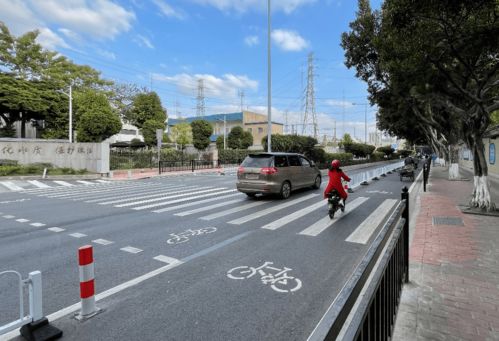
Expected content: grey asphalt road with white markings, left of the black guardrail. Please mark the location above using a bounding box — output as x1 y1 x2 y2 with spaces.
0 163 420 340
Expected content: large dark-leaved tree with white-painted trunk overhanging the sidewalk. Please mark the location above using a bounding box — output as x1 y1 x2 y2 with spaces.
342 0 499 210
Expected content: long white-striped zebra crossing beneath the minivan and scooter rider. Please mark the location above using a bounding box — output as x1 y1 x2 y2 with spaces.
16 181 398 240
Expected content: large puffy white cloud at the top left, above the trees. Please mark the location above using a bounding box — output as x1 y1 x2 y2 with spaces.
27 0 135 39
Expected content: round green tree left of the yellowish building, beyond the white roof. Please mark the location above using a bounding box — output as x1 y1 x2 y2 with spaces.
124 92 167 129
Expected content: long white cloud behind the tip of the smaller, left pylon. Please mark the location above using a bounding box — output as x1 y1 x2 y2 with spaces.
153 73 258 99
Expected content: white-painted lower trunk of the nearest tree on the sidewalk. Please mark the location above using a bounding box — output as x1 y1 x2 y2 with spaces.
470 137 495 211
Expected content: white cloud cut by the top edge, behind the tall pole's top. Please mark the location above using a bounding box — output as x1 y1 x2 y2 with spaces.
191 0 317 14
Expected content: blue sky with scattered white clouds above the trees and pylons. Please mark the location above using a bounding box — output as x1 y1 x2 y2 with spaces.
0 0 381 141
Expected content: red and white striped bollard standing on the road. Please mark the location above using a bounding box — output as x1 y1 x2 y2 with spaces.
76 245 99 320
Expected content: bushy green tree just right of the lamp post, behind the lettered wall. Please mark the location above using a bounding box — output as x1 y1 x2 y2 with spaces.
77 91 121 142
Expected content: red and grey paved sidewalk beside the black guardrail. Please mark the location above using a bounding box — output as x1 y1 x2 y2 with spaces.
393 167 499 341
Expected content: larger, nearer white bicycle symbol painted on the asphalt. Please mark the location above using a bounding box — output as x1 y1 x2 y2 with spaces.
227 262 302 293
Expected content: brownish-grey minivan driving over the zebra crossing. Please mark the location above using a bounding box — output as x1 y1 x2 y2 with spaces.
236 153 322 199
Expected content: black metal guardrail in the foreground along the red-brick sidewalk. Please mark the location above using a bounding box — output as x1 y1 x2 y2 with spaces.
308 187 409 341
